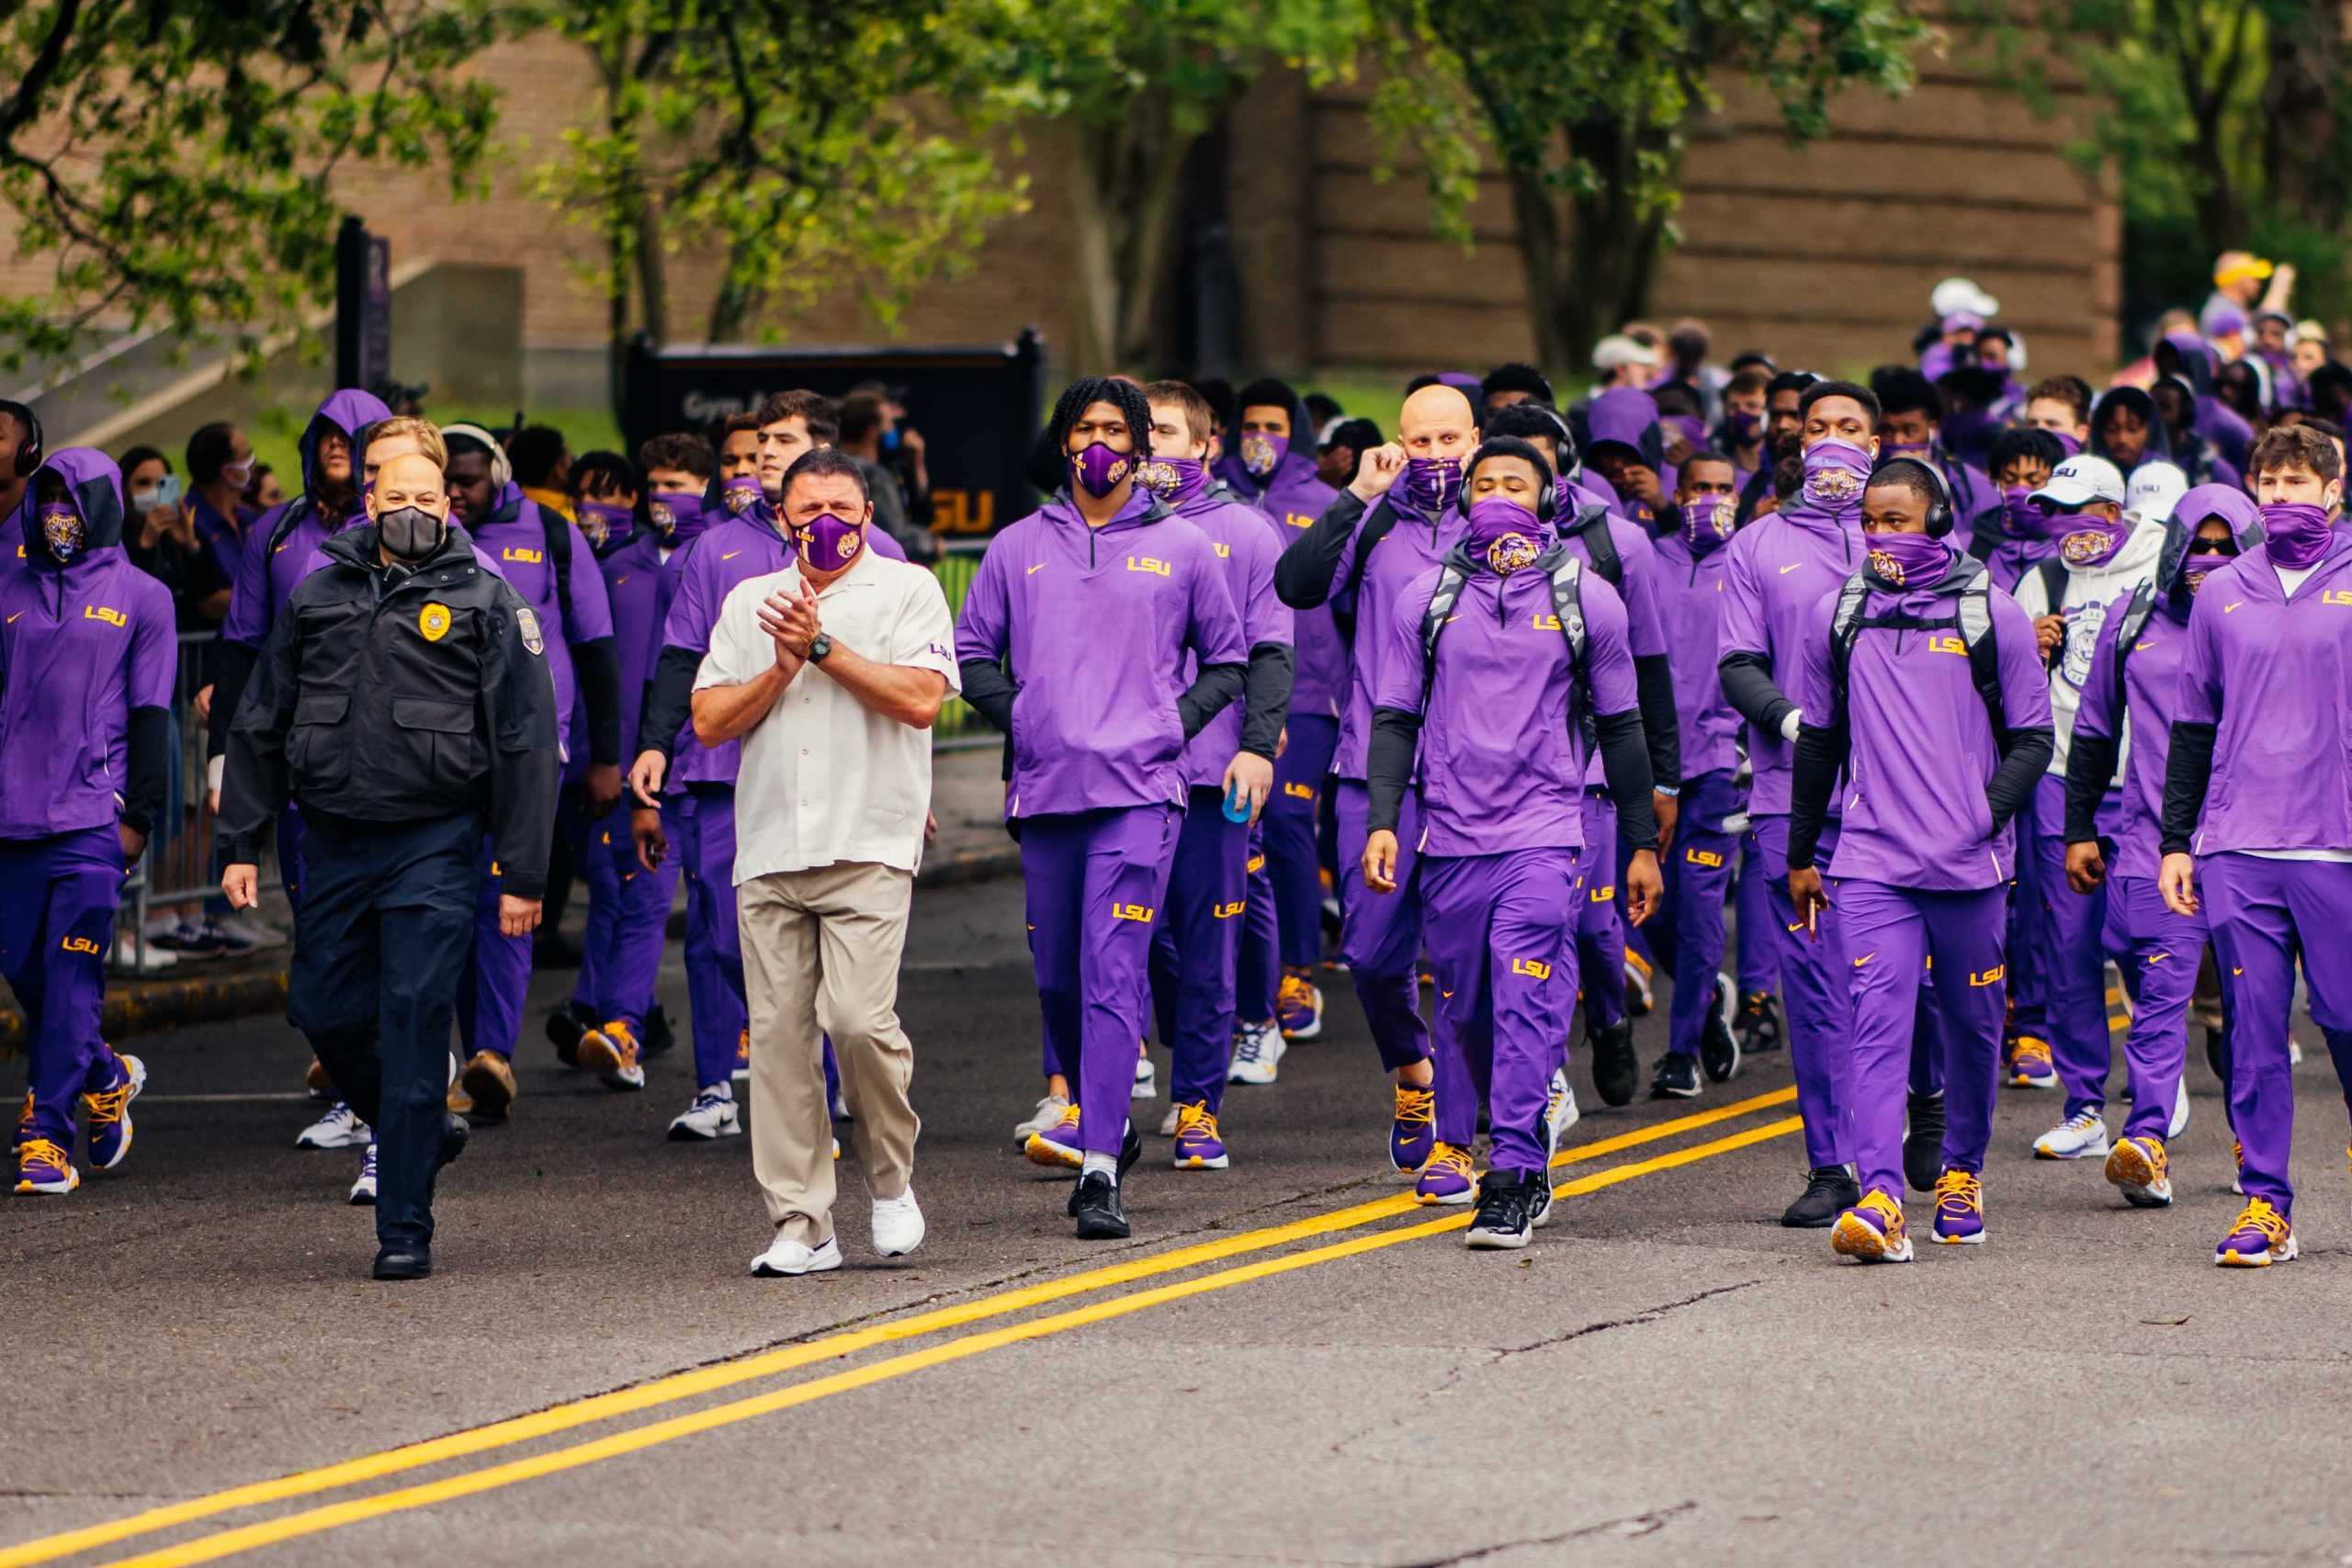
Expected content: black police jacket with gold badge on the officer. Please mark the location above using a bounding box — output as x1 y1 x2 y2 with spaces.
219 525 562 898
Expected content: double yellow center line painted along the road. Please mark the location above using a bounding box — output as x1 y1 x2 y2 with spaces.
0 1089 1802 1568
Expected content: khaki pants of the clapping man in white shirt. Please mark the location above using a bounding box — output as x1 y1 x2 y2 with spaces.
736 863 922 1246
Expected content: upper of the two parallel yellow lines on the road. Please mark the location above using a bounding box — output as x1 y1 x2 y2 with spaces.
0 1089 1797 1568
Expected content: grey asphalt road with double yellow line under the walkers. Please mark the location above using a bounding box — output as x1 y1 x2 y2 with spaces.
0 882 2352 1568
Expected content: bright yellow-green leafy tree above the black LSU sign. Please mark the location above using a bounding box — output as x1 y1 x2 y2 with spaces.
537 0 1030 400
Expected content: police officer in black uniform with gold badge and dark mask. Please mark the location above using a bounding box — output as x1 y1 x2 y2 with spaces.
219 456 560 1279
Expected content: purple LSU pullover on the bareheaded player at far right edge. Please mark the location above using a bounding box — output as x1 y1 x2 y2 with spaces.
2173 525 2352 856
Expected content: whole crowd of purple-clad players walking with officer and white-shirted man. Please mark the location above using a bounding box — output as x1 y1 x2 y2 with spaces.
0 254 2352 1279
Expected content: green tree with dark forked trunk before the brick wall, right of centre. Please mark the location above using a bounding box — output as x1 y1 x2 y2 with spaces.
1374 0 1924 367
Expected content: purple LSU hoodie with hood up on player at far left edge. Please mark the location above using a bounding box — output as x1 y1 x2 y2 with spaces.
0 446 179 841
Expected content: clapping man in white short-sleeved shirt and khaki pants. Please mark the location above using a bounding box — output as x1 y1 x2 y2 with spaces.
694 449 959 1274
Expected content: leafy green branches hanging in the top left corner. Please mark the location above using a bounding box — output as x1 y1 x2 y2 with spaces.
0 0 496 369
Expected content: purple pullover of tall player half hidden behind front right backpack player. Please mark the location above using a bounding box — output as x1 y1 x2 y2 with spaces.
1714 491 1862 818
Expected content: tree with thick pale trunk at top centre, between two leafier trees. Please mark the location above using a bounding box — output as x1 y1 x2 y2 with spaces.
1004 0 1371 367
